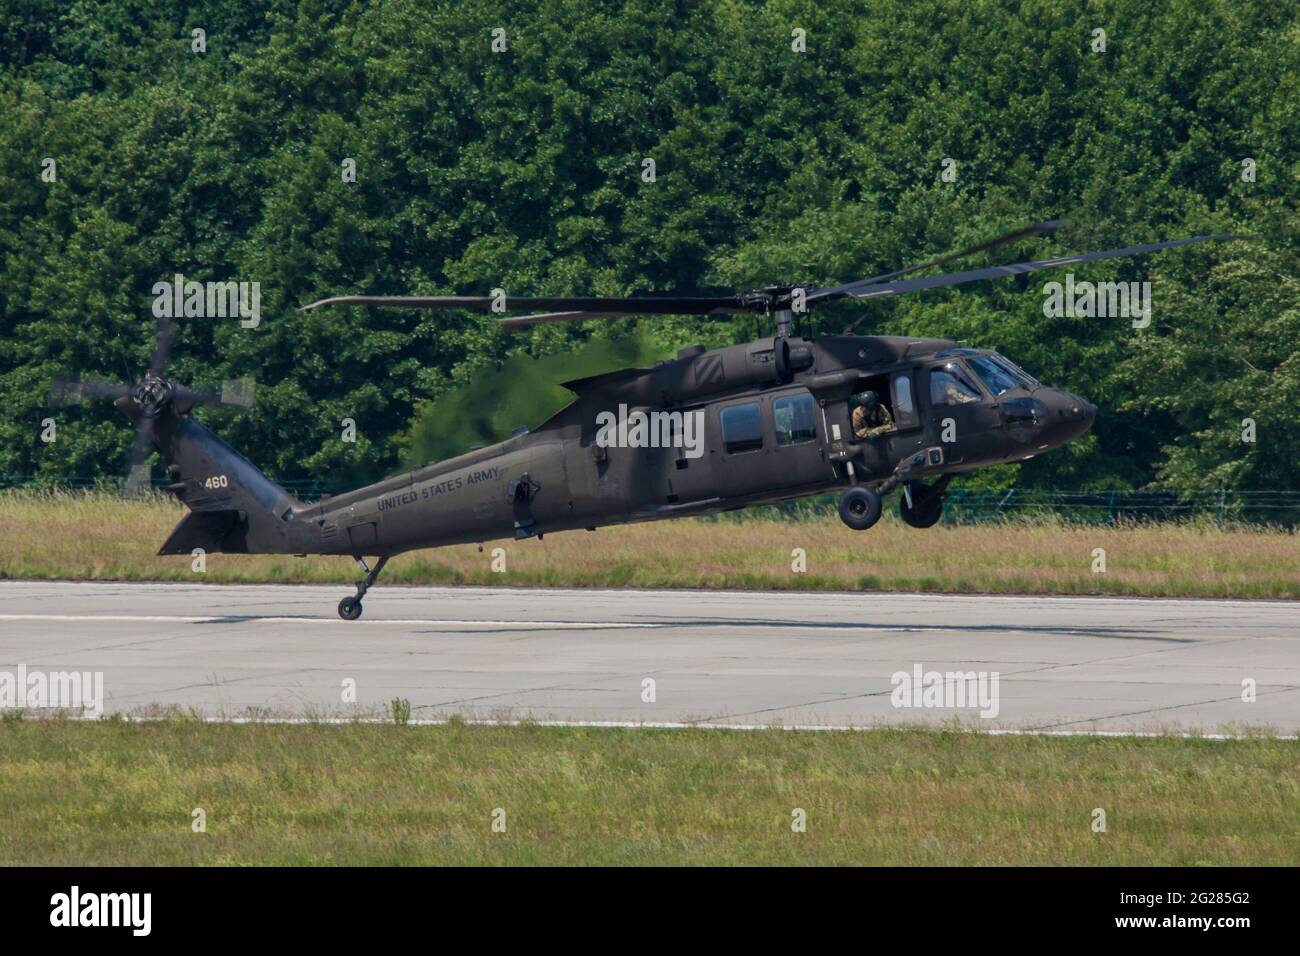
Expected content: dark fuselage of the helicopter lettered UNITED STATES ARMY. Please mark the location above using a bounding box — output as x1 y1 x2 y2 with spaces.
282 336 1096 555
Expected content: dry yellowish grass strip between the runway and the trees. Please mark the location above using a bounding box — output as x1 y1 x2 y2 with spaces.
0 492 1300 598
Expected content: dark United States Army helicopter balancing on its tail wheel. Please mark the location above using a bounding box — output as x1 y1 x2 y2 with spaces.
53 220 1234 620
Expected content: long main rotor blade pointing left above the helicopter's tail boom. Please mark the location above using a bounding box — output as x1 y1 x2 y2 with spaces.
298 295 763 321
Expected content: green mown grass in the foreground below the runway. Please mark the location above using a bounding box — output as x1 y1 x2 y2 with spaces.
0 719 1300 865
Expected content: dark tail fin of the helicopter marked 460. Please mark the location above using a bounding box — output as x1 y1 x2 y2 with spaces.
155 411 307 554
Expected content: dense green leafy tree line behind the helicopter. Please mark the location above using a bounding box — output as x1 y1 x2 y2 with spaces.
0 0 1300 489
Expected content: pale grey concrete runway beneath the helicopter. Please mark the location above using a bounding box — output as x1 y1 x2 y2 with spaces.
0 581 1300 734
